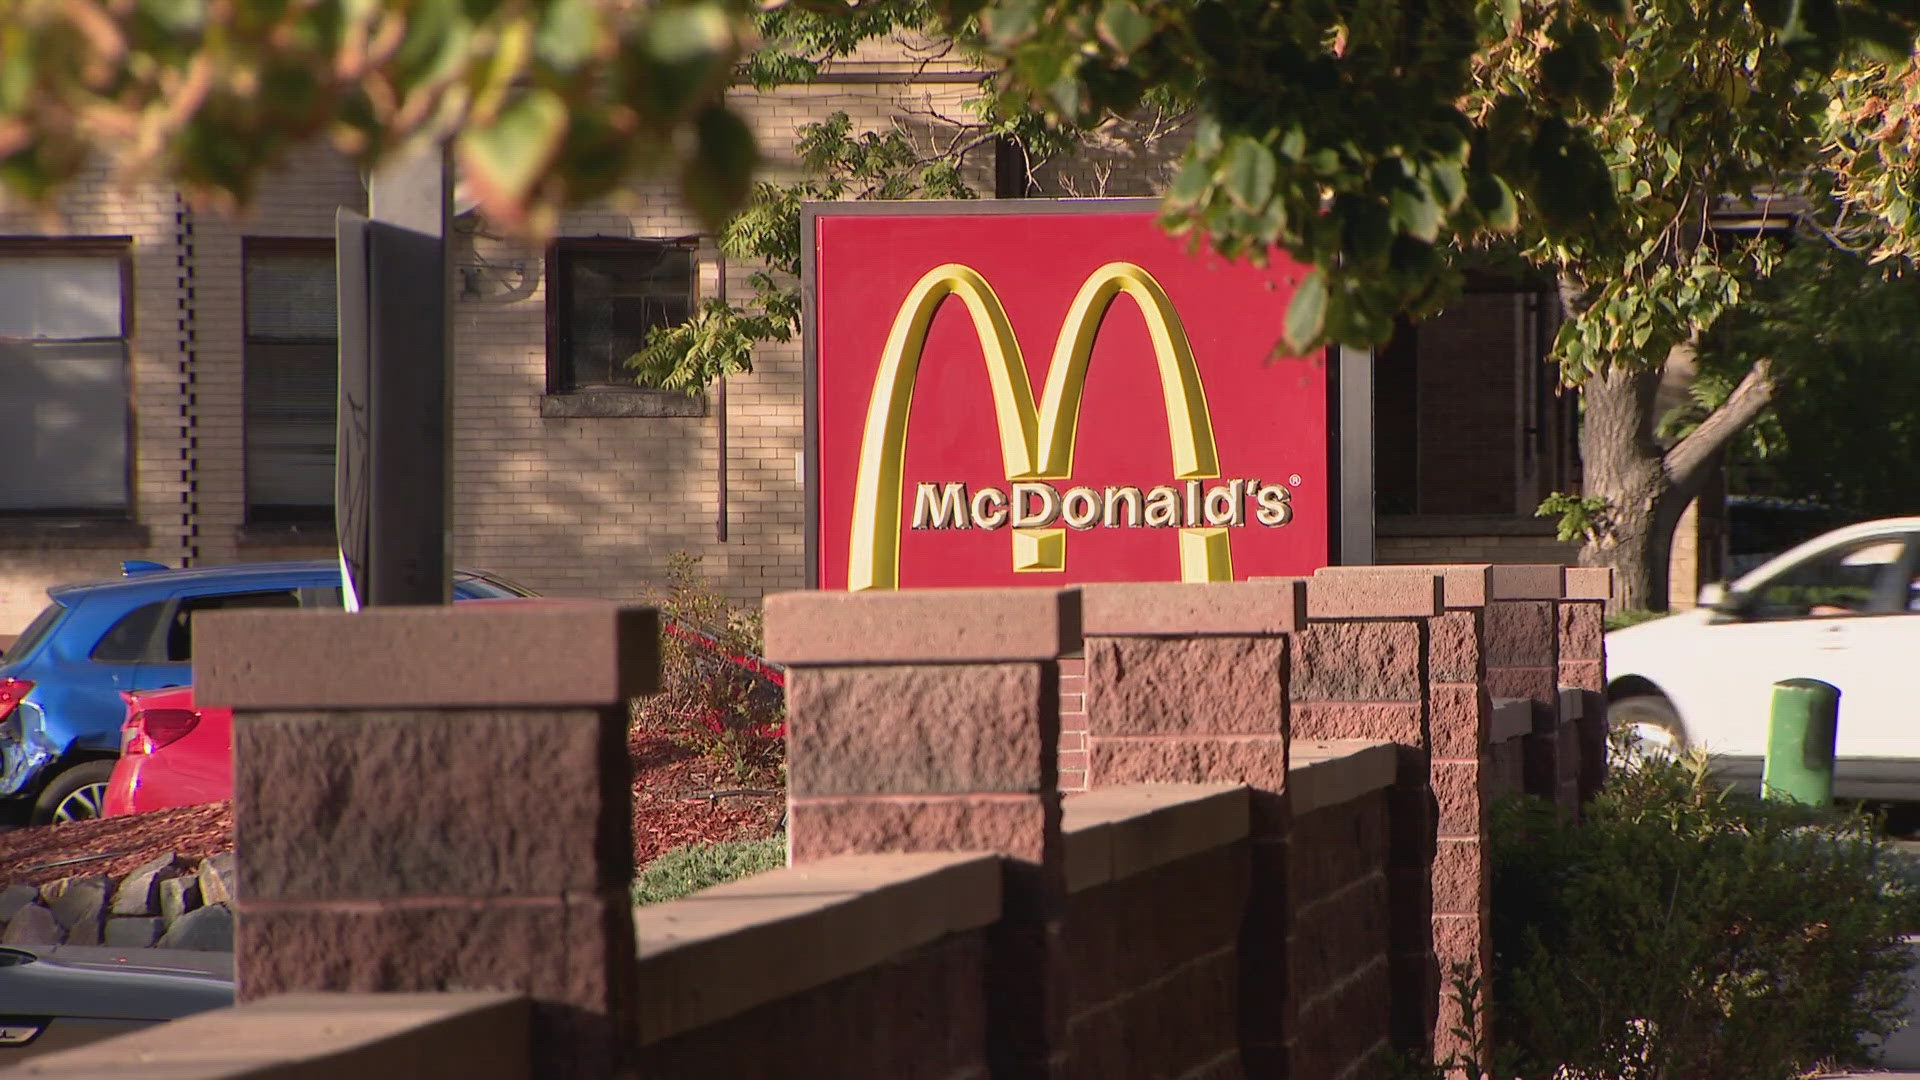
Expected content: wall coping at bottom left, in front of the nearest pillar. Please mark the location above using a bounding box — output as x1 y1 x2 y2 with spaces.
13 990 534 1080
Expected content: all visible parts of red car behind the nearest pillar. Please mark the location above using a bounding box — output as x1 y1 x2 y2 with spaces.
102 614 787 817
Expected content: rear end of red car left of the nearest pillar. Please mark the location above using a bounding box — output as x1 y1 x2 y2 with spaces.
102 686 234 817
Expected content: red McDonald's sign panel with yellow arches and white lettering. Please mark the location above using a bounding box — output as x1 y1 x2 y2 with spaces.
804 200 1338 590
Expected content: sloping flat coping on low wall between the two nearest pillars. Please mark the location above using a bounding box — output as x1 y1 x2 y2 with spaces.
634 851 1002 1045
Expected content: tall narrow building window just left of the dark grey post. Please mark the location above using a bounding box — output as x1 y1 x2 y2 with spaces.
242 238 340 525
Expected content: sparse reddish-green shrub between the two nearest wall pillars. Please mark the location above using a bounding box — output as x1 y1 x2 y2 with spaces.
634 553 787 786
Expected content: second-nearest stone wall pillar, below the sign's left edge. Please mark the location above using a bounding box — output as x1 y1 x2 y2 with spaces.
766 588 1081 1078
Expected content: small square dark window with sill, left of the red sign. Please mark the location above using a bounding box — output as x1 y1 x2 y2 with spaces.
547 238 693 394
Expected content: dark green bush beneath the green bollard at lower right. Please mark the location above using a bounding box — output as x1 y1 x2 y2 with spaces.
1490 759 1920 1080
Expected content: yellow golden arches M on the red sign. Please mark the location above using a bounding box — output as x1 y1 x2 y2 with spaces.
847 263 1233 590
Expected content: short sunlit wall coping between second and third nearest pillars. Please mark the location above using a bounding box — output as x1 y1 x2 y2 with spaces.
1062 784 1250 892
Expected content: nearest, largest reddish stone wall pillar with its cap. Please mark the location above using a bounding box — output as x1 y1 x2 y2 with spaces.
194 601 659 1078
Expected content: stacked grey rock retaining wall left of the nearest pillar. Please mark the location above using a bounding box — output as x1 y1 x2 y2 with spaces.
0 851 234 951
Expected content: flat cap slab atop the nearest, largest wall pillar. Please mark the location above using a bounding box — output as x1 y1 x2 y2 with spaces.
194 600 660 709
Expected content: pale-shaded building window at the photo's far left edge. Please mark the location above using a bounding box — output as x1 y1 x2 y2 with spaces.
0 238 132 519
